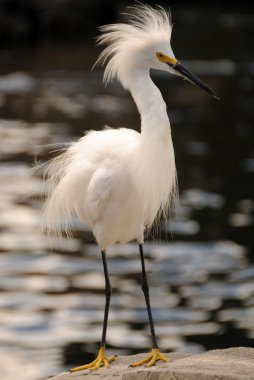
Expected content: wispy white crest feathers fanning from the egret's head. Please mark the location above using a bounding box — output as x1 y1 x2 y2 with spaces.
94 3 172 84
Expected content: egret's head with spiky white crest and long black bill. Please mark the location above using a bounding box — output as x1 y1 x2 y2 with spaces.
96 3 218 99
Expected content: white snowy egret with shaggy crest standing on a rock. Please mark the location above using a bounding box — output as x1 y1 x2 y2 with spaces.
44 3 217 372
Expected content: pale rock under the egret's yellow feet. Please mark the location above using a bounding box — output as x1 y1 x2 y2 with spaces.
46 347 254 380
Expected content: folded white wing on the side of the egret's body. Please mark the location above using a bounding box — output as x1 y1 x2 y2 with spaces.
87 168 115 222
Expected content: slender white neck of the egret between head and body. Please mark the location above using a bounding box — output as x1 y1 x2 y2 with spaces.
129 70 170 140
